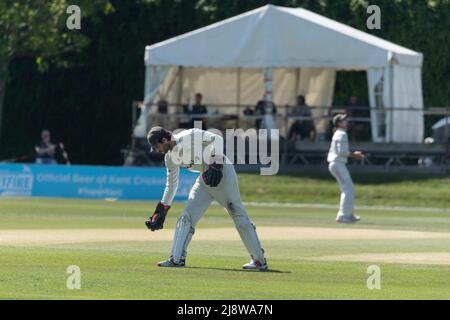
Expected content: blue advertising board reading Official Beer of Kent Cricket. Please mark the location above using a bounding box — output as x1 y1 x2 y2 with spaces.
0 164 198 200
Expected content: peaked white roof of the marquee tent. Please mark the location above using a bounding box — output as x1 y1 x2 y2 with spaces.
146 4 423 69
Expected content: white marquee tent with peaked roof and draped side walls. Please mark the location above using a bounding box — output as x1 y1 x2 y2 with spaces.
135 5 423 143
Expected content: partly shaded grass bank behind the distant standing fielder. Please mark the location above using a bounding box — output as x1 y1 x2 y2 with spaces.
239 172 450 208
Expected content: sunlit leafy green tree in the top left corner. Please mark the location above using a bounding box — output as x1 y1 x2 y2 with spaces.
0 0 112 138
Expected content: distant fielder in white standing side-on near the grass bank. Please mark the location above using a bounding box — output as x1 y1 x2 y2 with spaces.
327 114 364 223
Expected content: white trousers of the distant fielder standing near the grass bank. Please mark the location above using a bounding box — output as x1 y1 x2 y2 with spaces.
328 161 355 217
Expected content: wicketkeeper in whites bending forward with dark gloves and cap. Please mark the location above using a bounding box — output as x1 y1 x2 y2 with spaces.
146 127 268 271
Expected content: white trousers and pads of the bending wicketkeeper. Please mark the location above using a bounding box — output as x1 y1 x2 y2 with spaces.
171 164 265 263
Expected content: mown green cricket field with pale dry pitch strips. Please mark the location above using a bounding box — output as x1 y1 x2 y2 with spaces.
0 184 450 299
